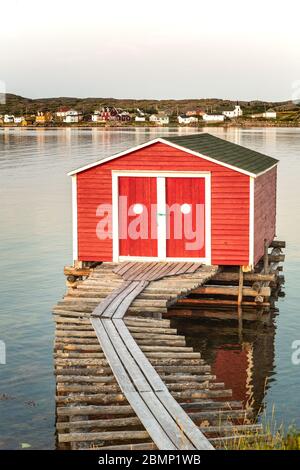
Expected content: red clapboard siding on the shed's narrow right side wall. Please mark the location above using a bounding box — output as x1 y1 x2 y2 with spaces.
254 167 277 264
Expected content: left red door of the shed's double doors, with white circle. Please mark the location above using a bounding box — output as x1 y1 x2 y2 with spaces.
118 176 157 257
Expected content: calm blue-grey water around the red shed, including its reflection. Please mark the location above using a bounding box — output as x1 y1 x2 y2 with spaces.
0 129 300 449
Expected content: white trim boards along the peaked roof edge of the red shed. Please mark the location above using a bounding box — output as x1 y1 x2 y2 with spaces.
68 137 278 178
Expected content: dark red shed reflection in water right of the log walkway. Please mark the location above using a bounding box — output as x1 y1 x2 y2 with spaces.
172 314 275 416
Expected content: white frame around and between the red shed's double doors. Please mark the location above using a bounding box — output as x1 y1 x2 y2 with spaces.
112 170 211 265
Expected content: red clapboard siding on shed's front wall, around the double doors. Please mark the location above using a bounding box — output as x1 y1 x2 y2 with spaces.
77 143 249 265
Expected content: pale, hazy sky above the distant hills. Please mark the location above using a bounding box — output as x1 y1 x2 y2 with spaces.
0 0 300 101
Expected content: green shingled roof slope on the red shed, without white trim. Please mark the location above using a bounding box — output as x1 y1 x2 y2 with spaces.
162 133 278 175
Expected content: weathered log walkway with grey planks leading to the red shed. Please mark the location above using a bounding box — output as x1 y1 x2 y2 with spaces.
54 262 258 450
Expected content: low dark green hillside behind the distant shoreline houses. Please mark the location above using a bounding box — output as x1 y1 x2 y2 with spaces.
0 93 300 115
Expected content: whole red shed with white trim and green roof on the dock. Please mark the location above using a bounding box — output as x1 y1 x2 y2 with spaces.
69 133 278 270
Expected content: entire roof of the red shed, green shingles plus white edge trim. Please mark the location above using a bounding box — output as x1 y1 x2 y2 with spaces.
68 133 278 177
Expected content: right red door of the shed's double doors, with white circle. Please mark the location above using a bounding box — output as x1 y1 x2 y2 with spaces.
166 177 205 258
